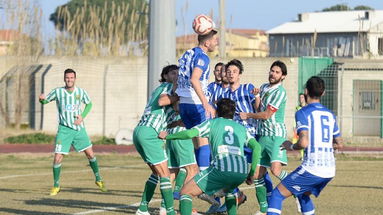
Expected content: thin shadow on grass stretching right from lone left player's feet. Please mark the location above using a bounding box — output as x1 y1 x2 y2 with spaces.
61 187 142 198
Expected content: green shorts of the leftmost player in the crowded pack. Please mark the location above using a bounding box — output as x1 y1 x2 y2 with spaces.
133 126 168 165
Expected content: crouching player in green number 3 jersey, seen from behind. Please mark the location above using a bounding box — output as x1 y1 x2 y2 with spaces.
166 99 260 215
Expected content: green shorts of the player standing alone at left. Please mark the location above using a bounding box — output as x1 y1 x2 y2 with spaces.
55 125 92 154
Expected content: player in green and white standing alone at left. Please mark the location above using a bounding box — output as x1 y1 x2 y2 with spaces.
39 69 107 196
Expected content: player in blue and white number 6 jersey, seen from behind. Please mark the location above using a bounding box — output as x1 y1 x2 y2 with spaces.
267 76 343 215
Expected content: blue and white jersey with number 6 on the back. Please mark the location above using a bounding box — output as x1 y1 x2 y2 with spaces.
295 103 340 178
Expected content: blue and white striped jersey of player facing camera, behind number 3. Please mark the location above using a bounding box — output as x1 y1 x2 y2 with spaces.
219 84 257 136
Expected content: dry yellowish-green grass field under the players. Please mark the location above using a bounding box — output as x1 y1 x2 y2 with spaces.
0 153 383 215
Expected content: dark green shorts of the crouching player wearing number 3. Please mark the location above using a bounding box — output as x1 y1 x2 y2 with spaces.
194 166 247 195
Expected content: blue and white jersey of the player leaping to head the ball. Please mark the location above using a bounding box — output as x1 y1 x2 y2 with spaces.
176 47 210 104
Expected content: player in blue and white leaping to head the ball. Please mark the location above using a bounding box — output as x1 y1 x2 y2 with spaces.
176 29 218 173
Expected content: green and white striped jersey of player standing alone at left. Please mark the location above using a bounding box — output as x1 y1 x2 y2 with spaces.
46 87 91 130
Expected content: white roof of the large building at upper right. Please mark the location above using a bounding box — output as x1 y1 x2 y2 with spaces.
267 10 383 34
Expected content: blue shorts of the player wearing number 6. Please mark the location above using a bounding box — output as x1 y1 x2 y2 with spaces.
281 166 332 197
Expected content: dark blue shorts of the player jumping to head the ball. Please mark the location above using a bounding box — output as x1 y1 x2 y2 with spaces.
179 104 206 129
